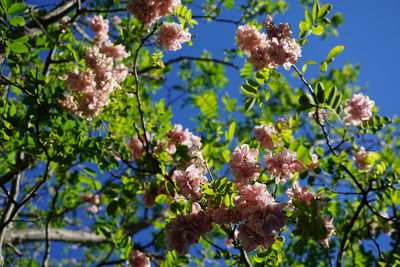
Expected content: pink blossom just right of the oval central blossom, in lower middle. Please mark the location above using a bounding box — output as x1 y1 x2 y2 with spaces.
264 148 304 184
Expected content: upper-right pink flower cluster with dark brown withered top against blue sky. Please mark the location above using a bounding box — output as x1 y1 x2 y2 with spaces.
236 16 301 71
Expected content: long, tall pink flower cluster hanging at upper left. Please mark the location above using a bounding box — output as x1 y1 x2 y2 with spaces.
59 16 129 118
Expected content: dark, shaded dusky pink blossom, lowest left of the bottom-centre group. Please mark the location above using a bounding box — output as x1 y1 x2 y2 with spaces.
165 211 212 255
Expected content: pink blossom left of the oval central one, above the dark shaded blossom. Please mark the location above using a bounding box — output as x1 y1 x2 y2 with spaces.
172 165 208 200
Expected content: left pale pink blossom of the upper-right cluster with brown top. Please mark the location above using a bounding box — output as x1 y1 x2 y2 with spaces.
236 24 265 54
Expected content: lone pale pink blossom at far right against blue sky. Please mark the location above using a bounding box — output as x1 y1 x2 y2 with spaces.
343 93 375 126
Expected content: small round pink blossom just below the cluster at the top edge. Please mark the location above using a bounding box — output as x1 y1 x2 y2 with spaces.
157 22 191 51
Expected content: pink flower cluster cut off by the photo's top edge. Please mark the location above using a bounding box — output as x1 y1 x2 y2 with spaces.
126 0 181 25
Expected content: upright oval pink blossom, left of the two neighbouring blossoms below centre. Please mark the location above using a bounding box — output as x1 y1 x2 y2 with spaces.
229 144 260 184
